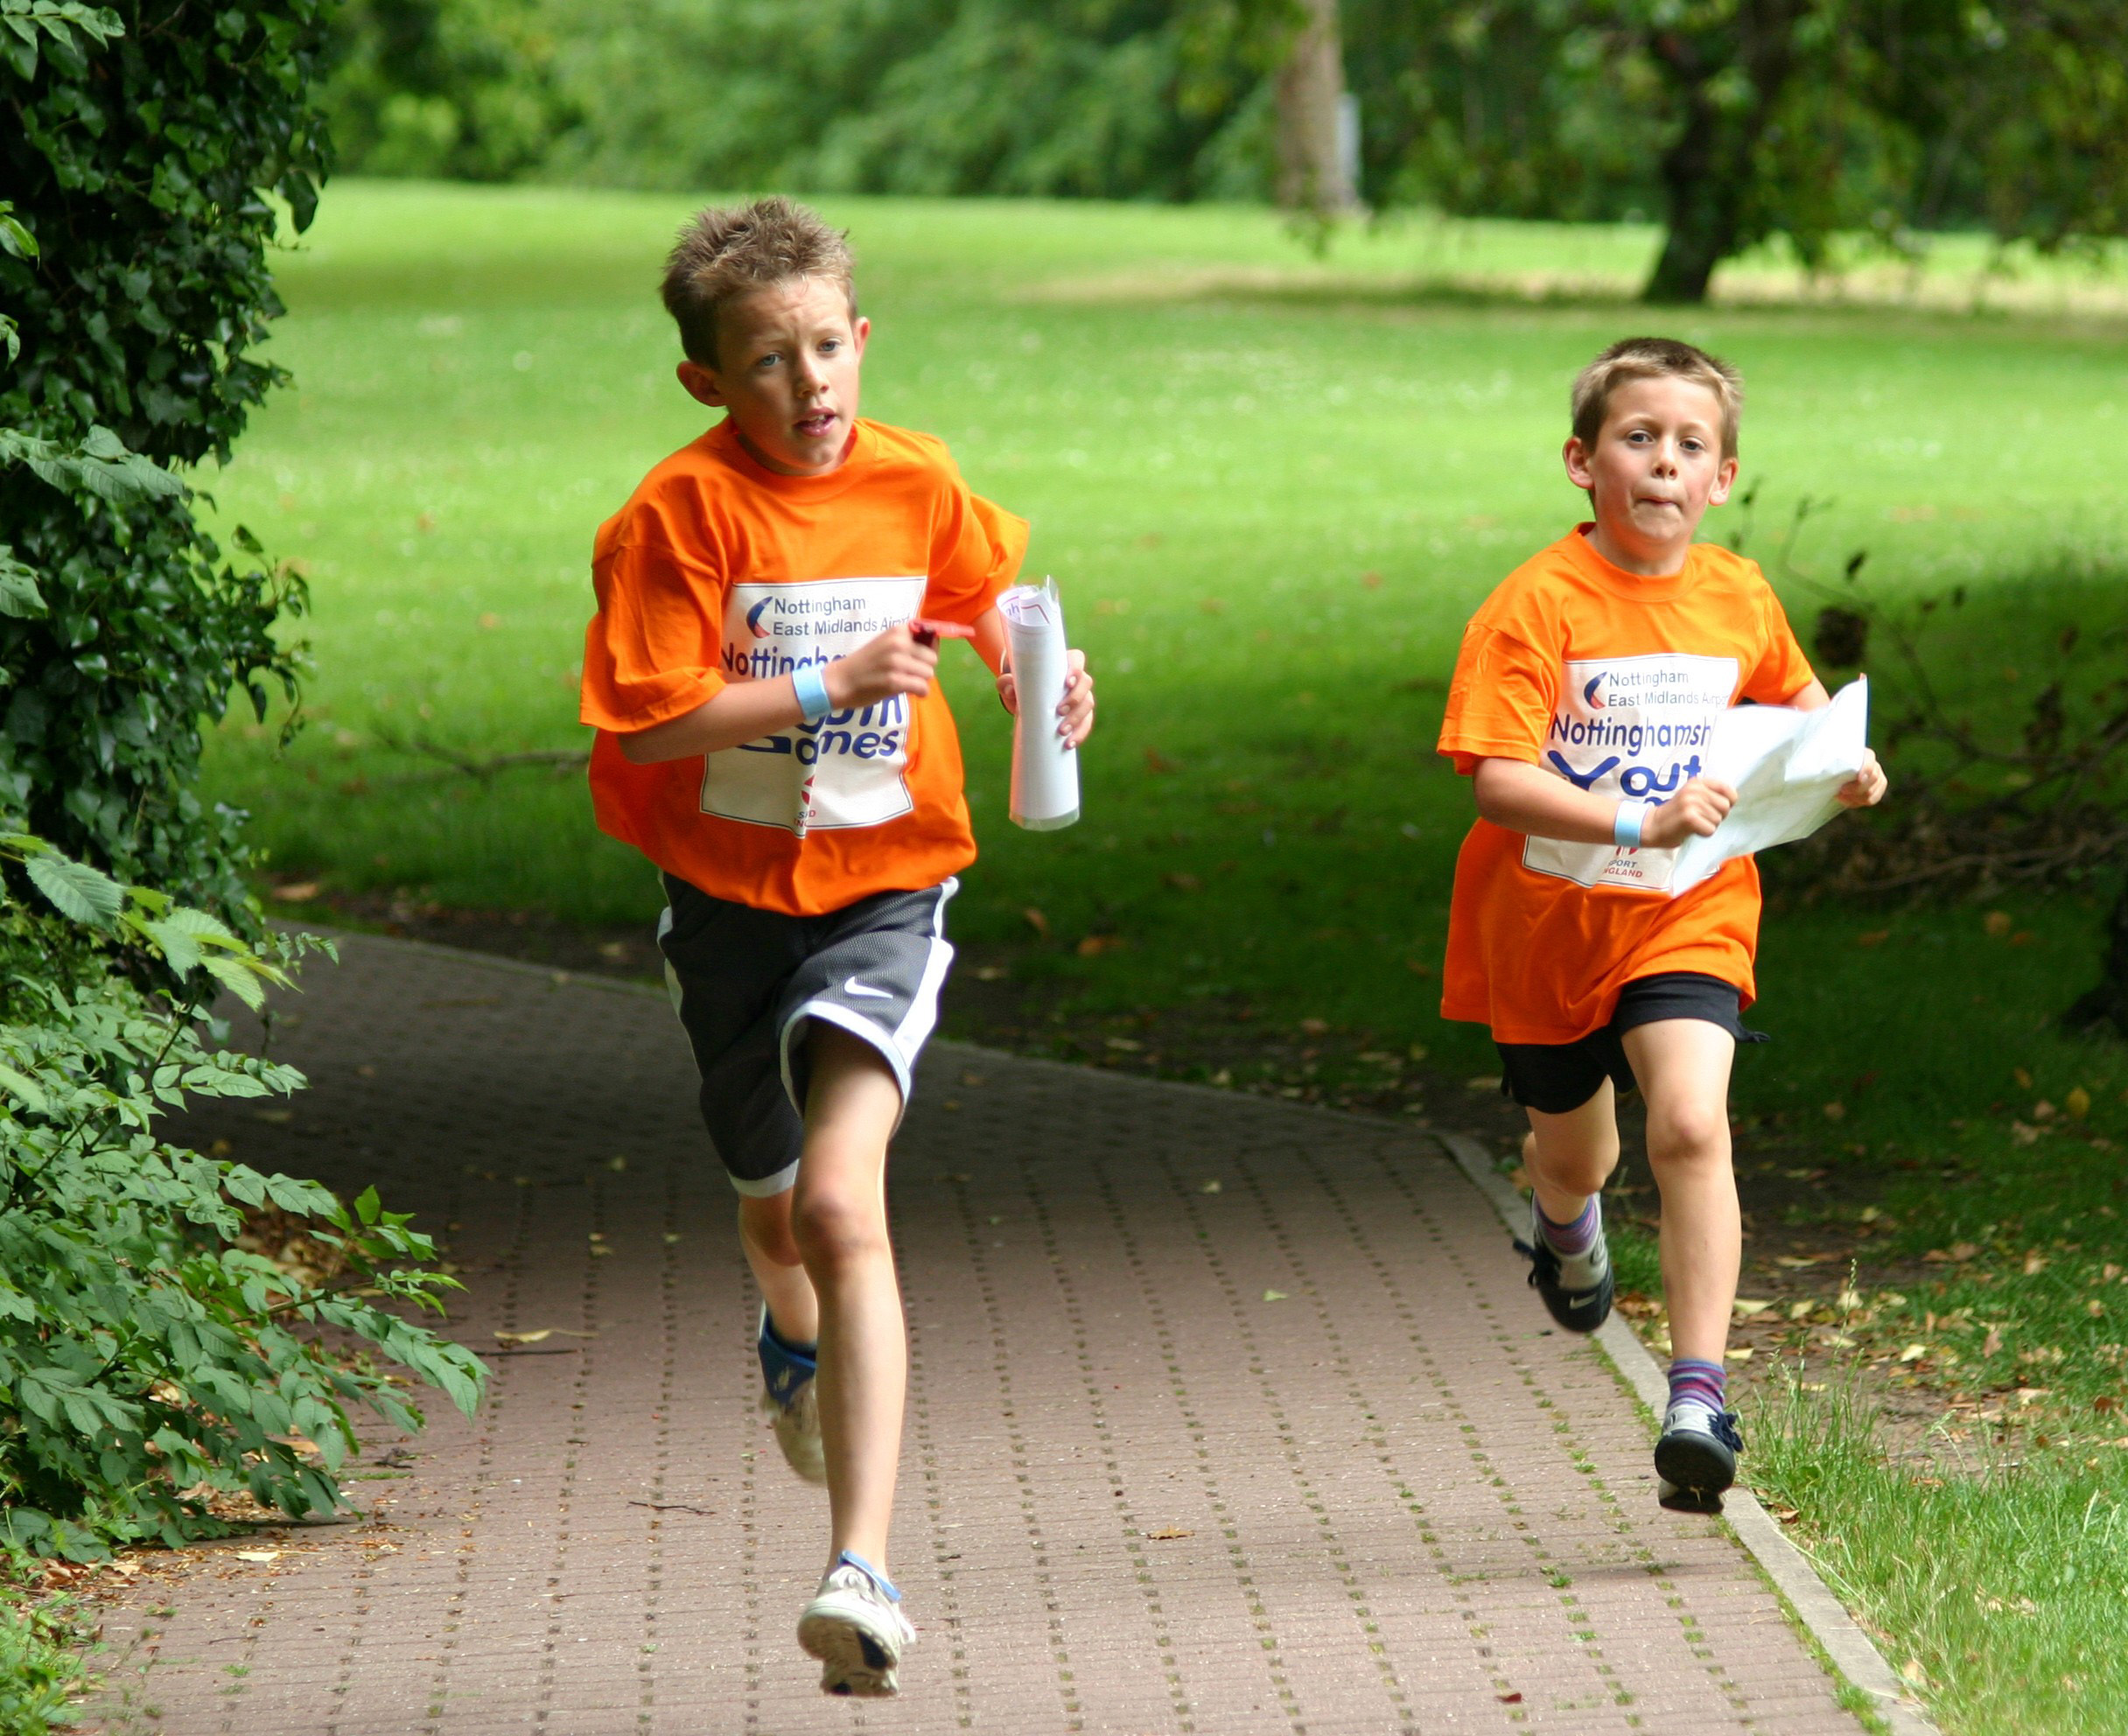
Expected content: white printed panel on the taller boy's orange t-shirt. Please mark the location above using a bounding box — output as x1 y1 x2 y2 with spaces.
703 574 928 838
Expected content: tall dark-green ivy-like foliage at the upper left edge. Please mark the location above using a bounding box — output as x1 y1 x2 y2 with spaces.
0 0 328 914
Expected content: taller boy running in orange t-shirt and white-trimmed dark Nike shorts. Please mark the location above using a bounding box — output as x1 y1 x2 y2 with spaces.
583 198 1094 1696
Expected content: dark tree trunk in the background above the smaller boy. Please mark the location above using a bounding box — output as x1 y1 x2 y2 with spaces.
1641 0 1809 304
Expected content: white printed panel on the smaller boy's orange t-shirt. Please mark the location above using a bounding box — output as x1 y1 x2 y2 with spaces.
1522 651 1739 892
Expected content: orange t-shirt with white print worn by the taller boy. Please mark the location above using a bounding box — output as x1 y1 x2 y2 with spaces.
581 419 1028 917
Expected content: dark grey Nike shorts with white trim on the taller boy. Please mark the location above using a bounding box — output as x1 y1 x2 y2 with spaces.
657 874 960 1198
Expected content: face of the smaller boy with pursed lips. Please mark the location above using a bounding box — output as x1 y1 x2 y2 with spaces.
1566 376 1737 570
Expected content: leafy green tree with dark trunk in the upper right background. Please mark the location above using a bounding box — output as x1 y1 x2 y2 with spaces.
1345 0 2128 302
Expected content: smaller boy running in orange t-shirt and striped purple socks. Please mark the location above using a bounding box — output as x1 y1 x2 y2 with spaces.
1440 339 1886 1513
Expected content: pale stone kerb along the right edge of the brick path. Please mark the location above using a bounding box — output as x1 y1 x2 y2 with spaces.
1432 1131 1942 1736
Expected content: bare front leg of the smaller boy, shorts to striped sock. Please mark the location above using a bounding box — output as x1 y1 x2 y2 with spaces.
1624 1019 1743 1368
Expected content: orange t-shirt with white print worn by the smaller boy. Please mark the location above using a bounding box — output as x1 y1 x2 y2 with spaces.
1440 526 1811 1042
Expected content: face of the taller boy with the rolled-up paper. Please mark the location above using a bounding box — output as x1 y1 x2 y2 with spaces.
679 276 872 477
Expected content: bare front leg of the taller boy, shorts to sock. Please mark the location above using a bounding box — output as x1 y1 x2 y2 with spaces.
792 1019 908 1572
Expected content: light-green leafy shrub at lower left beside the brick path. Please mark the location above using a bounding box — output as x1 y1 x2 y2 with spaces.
0 832 485 1559
